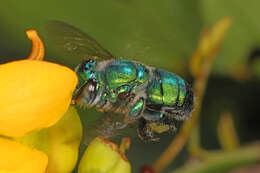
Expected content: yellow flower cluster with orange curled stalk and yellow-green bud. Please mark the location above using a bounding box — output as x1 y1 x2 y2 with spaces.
0 30 131 173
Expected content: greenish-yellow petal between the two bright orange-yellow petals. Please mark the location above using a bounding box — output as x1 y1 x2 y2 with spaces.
16 106 82 173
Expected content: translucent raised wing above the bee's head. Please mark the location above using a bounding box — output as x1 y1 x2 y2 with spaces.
46 21 113 61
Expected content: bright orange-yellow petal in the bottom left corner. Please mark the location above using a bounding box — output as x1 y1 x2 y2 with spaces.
0 138 48 173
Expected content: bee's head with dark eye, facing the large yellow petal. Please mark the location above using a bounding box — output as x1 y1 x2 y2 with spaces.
72 59 99 106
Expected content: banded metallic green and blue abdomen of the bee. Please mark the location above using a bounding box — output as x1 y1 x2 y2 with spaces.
147 69 193 117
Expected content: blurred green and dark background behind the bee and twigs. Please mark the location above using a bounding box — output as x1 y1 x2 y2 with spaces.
0 0 260 172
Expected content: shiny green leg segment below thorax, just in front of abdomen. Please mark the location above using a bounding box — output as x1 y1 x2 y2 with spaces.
125 97 145 123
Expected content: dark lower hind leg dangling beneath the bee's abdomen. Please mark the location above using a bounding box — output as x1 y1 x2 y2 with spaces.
137 118 159 142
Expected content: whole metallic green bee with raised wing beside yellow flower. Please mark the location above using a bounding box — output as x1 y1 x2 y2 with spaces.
45 21 194 141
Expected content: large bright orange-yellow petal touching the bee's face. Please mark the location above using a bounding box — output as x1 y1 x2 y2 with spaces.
0 60 77 136
